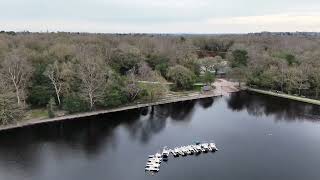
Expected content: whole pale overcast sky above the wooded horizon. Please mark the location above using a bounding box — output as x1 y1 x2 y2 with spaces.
0 0 320 33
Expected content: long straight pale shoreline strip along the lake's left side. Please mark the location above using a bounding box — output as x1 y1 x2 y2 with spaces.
0 92 233 131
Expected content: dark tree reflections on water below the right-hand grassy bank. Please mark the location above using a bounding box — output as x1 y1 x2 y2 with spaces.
228 91 320 122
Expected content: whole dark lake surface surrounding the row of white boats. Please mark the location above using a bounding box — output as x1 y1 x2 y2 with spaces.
0 92 320 180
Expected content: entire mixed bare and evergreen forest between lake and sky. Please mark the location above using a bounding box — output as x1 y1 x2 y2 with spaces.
0 32 320 125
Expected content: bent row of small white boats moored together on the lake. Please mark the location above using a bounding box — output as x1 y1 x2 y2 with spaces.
145 142 218 172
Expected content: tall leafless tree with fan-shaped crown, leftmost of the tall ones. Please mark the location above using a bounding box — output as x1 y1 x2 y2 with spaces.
2 50 32 105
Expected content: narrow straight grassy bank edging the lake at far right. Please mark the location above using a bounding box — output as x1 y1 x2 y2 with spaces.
247 88 320 105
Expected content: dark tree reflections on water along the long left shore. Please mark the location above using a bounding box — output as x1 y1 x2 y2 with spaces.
0 100 200 174
